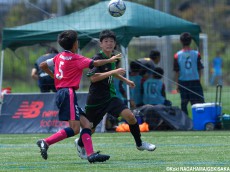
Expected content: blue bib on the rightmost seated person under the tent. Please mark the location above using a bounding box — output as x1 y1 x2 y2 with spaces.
143 78 165 105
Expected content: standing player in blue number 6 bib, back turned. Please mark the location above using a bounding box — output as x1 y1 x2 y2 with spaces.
173 32 204 114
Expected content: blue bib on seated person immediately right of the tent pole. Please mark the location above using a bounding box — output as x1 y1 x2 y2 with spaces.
129 75 142 105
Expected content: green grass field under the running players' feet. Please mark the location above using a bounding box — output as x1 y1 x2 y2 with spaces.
0 131 230 172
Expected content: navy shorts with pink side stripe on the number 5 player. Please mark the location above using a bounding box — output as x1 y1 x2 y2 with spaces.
56 88 85 121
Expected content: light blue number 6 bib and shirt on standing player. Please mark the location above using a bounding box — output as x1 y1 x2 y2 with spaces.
174 49 203 81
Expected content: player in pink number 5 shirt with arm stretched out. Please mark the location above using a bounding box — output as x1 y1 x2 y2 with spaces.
37 30 121 163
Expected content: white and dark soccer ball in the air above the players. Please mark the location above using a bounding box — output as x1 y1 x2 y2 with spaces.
108 0 126 17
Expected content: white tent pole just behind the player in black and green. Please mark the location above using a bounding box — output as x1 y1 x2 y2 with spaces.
121 46 130 108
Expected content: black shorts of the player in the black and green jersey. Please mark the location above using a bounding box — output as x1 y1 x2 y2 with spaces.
85 97 128 128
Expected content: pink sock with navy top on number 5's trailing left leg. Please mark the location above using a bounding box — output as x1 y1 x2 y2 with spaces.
44 127 74 145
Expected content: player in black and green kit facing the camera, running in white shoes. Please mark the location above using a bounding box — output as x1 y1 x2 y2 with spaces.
75 30 156 159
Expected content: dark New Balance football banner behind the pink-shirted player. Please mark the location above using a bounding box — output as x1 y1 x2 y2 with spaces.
0 93 87 134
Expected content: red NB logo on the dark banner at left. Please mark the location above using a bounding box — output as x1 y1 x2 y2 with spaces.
12 101 44 118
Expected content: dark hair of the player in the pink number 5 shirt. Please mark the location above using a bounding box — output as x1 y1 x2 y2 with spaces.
58 30 77 50
